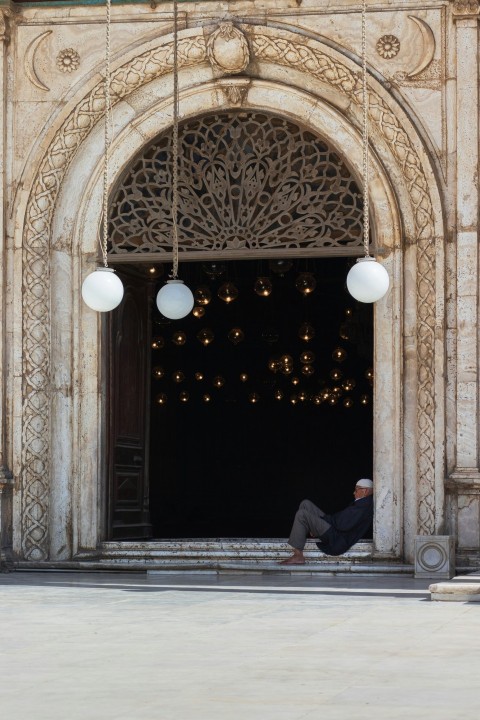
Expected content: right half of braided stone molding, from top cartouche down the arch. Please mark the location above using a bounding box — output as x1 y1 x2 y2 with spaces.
252 35 435 535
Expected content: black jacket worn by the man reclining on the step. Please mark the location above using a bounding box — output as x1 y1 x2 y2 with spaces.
317 495 373 555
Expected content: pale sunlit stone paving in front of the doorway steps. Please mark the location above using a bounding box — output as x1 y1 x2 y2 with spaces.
0 572 480 720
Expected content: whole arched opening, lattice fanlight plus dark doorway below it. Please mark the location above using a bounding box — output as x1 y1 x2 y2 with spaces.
108 111 373 538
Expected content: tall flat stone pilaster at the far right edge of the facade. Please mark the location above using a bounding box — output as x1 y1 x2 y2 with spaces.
447 0 480 564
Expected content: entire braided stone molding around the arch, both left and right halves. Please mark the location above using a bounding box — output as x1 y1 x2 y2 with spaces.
22 29 435 560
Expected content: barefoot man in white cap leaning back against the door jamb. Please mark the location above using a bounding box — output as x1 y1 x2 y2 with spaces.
280 478 373 565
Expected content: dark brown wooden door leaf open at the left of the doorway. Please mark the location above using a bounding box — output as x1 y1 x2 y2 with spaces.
107 268 153 540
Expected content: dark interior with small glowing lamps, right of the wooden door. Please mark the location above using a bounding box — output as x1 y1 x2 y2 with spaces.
149 258 373 539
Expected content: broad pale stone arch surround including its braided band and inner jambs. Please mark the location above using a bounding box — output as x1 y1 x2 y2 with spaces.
22 26 444 559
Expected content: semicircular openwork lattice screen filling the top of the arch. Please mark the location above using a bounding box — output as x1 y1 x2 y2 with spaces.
109 111 363 255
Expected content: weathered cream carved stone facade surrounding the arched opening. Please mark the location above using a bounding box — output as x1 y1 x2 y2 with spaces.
0 0 480 565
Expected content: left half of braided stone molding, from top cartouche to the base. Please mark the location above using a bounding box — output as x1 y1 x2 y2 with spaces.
22 36 205 560
